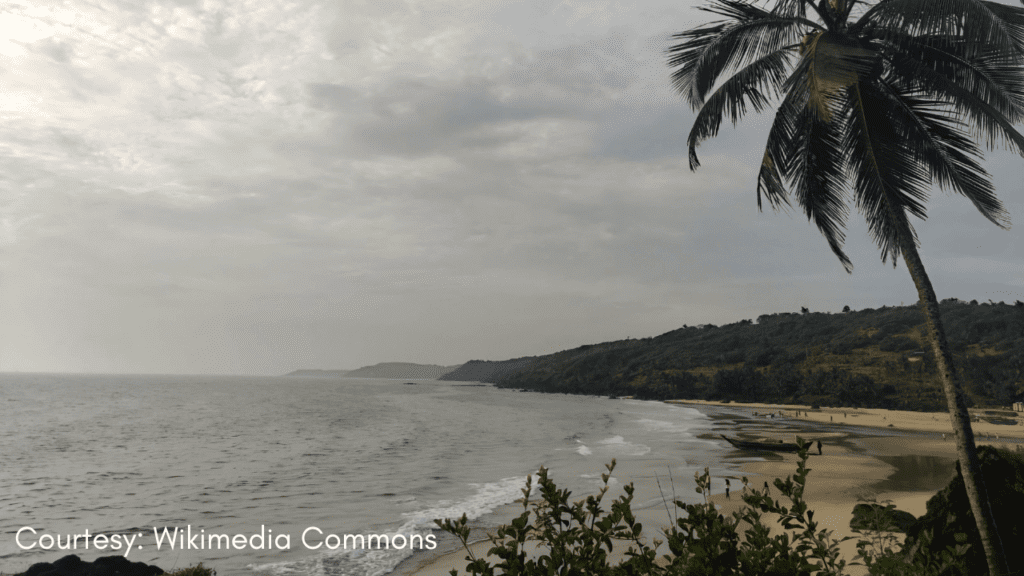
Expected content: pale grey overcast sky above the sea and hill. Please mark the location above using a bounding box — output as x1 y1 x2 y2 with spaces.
0 0 1024 374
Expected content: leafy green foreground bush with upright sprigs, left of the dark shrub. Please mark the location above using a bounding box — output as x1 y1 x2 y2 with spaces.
435 439 849 576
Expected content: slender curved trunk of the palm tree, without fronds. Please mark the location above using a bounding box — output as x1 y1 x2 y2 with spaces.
900 236 1010 576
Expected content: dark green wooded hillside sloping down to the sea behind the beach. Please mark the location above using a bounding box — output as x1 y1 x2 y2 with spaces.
490 298 1024 411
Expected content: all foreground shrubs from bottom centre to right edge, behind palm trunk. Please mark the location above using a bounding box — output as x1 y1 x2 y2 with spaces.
435 446 1024 576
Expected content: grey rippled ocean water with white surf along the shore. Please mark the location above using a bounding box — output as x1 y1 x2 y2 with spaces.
0 374 730 576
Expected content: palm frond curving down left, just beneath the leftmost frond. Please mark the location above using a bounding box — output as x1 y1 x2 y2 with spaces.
687 50 791 170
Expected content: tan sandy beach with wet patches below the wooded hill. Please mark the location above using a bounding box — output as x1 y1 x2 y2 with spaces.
412 401 1024 576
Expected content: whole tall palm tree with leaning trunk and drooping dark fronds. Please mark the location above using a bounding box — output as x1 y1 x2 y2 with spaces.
668 0 1024 575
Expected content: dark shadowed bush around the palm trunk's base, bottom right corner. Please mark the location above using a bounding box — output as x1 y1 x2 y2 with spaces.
903 446 1024 575
